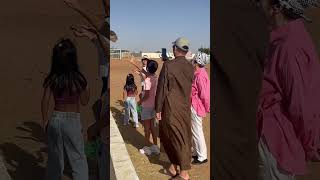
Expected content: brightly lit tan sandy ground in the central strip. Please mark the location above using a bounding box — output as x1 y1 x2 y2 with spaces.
110 60 210 180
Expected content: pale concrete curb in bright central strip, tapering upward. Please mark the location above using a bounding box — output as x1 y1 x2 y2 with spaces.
110 111 139 180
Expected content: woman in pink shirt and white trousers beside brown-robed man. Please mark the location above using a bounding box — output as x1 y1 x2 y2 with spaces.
191 52 210 164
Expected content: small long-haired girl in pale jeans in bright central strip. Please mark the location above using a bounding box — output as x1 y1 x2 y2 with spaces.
123 74 139 128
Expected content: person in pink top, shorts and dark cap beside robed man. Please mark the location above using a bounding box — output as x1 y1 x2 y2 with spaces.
138 60 160 155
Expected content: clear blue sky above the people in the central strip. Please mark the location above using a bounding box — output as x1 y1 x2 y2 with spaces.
110 0 210 52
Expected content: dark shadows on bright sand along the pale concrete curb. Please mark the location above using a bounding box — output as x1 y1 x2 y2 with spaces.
110 100 170 167
